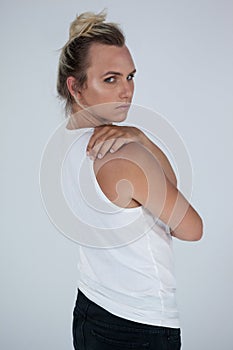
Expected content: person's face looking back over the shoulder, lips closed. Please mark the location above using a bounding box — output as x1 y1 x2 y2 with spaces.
75 44 136 123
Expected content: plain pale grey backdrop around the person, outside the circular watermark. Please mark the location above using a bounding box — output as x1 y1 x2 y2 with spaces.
0 0 233 350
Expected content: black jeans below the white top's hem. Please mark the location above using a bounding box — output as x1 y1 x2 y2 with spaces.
73 290 181 350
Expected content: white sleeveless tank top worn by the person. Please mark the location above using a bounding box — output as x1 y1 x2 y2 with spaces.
62 128 179 328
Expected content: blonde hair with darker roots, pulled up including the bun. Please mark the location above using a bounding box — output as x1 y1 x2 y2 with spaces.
57 11 125 113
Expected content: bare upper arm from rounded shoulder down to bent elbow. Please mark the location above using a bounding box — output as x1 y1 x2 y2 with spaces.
94 143 202 240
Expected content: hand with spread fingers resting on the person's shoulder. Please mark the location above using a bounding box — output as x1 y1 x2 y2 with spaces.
87 125 145 159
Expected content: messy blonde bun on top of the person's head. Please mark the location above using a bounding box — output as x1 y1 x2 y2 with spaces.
69 11 106 41
